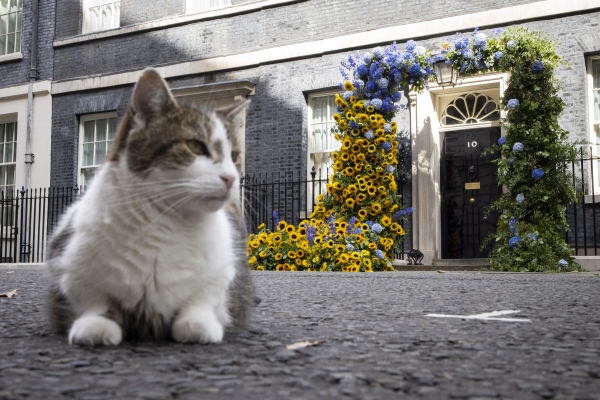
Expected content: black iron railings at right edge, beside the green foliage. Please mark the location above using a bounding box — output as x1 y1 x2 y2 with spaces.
564 150 600 256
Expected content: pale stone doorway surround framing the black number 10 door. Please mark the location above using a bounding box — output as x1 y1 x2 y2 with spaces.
410 73 508 265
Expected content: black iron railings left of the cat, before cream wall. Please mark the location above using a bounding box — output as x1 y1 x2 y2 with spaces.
0 187 79 263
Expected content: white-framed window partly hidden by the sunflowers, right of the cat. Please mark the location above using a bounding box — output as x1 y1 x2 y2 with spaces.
308 94 341 179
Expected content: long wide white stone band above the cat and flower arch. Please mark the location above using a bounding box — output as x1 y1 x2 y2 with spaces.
52 0 600 94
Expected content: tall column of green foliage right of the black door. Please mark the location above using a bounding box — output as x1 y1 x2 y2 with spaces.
486 28 580 272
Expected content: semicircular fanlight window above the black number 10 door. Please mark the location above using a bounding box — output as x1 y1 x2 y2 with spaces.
440 93 500 126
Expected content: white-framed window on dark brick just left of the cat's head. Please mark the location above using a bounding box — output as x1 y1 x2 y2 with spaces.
79 113 117 188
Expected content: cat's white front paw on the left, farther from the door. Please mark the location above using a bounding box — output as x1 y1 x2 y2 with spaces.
69 315 123 346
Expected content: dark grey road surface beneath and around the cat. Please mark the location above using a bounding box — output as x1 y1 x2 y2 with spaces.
0 270 600 400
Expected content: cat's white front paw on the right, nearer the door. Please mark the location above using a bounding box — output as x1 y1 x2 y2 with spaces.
172 314 223 343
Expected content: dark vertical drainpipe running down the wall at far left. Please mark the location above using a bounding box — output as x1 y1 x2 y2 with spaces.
20 0 38 262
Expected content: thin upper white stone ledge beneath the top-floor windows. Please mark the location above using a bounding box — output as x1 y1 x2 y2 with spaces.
52 0 305 47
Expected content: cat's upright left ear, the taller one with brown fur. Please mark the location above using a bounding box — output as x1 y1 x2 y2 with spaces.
131 68 177 120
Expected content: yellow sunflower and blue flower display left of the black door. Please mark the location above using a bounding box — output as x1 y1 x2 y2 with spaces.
247 41 433 272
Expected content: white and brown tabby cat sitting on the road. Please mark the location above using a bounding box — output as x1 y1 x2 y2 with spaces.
47 69 257 345
